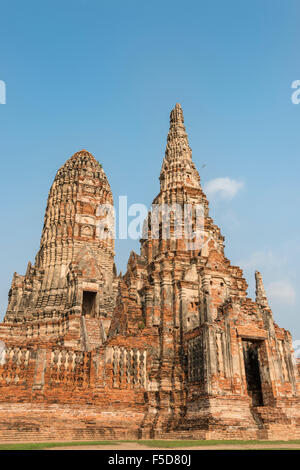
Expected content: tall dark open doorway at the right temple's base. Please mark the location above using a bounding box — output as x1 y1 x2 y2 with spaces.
243 340 263 406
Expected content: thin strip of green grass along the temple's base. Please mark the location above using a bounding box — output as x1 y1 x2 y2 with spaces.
0 440 300 450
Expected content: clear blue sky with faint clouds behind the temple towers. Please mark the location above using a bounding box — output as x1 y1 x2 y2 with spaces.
0 0 300 346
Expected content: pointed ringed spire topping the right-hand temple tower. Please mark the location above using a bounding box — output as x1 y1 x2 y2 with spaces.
160 103 200 191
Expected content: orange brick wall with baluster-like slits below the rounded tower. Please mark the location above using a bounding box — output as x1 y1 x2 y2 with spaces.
0 342 148 409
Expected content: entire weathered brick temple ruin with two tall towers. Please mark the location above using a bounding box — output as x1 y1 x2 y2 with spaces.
0 104 300 441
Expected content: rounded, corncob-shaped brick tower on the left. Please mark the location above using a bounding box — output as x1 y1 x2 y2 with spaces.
6 150 114 321
